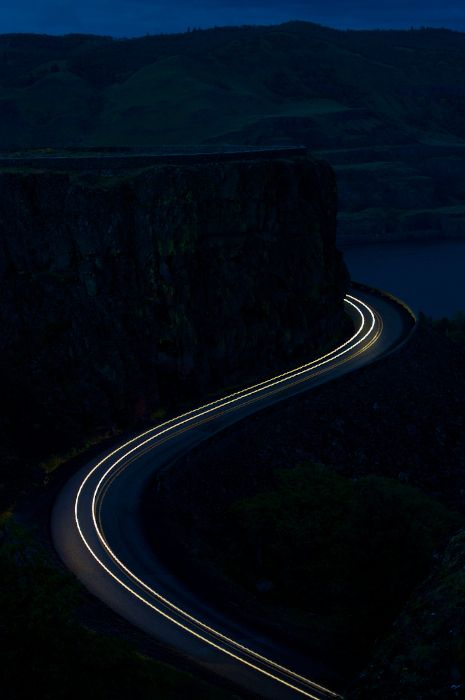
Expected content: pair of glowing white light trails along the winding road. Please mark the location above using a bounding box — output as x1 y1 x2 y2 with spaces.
74 295 376 700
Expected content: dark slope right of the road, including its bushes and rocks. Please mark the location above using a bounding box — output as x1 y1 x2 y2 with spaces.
146 319 465 700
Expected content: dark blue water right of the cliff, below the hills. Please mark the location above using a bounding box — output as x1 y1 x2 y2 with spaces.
340 241 465 318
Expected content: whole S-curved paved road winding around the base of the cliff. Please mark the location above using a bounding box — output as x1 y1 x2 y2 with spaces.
52 292 414 700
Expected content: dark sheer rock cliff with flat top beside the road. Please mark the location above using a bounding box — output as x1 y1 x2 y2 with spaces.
0 152 347 482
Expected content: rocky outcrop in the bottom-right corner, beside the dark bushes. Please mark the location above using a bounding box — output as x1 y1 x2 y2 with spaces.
349 531 465 700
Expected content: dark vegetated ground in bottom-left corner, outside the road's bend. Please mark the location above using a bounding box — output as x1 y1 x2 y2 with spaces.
0 518 230 700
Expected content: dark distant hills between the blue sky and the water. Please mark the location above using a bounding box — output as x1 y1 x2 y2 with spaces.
0 22 465 239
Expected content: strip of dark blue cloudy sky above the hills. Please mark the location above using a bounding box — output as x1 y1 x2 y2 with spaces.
0 0 465 36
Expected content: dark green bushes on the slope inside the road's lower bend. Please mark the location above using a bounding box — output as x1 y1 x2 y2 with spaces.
217 463 462 657
